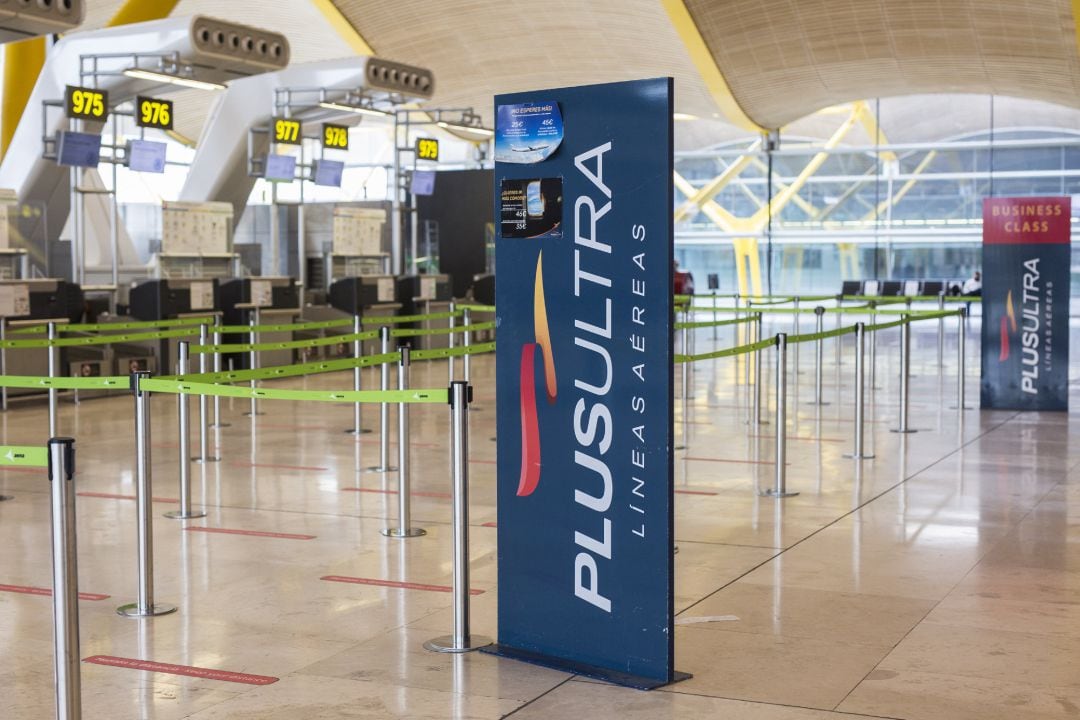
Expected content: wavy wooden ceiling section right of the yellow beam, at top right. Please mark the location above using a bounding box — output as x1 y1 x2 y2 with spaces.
686 0 1080 127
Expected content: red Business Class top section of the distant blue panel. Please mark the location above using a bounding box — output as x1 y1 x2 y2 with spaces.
983 198 1071 245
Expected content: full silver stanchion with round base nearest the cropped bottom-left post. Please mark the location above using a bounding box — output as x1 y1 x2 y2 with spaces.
117 370 176 617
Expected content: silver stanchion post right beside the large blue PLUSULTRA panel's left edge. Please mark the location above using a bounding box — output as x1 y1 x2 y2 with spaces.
423 382 491 653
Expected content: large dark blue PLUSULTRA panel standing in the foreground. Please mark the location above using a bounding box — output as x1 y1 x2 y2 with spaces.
491 78 685 688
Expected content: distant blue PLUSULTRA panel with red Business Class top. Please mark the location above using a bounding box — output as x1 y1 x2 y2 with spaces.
980 198 1072 410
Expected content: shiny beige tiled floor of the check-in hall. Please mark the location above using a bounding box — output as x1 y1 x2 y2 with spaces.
0 321 1080 720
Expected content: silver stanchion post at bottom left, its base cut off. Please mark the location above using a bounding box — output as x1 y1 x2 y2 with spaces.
49 437 82 720
